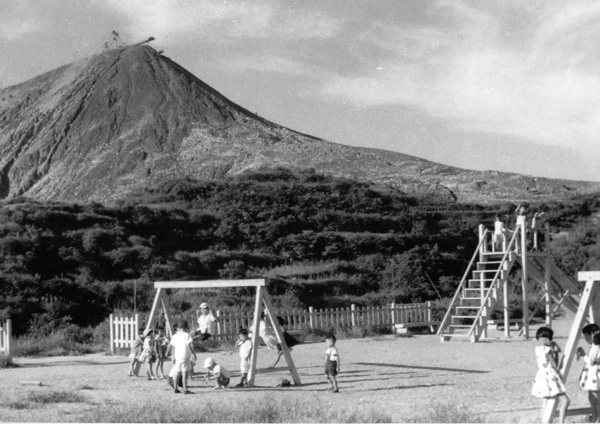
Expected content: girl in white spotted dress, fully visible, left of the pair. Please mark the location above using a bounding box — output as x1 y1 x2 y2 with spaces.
531 327 570 423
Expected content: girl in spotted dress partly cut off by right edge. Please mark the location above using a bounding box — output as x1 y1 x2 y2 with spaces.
577 324 600 423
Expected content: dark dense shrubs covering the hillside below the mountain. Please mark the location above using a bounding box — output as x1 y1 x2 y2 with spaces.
0 169 600 334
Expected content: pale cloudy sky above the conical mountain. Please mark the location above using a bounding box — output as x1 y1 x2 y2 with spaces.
0 0 600 181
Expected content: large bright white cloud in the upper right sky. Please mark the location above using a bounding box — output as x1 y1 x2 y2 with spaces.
324 1 600 150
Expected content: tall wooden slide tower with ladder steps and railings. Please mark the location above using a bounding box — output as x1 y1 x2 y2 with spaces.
438 219 582 342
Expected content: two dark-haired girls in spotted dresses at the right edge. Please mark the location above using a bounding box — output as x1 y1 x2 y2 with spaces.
531 324 600 423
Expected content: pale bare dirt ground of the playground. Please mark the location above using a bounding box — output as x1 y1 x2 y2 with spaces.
0 316 587 422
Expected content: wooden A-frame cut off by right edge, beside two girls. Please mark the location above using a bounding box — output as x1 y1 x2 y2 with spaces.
542 271 600 423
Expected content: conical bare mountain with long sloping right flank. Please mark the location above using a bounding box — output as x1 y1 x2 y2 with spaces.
0 46 600 202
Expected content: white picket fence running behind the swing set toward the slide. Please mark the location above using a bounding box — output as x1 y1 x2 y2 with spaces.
110 302 433 353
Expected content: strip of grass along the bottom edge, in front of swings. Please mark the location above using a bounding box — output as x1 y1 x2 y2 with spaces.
83 396 391 423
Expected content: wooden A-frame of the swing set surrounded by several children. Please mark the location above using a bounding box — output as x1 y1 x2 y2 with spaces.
146 279 301 386
